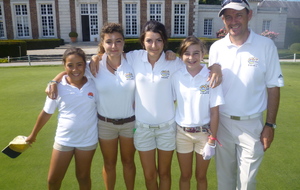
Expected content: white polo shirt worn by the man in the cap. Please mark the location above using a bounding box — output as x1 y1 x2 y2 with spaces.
209 30 284 116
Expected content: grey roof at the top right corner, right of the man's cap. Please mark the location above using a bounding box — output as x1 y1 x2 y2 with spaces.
258 1 300 18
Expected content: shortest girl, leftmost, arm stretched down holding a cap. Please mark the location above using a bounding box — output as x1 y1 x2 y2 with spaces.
26 48 98 189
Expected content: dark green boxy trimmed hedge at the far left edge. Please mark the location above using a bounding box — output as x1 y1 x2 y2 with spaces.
0 40 27 58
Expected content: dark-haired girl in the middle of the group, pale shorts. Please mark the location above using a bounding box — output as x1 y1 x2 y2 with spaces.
126 21 183 190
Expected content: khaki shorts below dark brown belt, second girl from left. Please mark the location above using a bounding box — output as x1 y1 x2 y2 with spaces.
98 119 135 139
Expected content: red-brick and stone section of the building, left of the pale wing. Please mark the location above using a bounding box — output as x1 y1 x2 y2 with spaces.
0 0 197 42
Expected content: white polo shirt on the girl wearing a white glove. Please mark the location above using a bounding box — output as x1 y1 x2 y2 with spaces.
172 64 224 127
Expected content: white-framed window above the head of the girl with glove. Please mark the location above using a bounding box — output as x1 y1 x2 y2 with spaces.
173 3 187 36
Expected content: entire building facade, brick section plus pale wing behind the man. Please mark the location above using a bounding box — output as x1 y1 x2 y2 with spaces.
0 0 296 47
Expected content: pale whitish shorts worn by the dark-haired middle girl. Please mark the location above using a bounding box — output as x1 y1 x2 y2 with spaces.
134 122 176 151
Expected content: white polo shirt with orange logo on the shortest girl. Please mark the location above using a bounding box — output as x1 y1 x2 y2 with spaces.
44 75 98 147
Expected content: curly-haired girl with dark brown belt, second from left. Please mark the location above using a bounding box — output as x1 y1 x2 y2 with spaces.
44 23 136 190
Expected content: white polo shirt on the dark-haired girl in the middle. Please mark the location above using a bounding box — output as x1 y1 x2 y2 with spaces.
126 50 183 124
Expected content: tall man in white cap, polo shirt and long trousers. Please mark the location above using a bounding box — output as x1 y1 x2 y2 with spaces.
209 0 283 190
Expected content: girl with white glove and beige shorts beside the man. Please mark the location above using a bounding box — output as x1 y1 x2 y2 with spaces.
172 36 224 190
